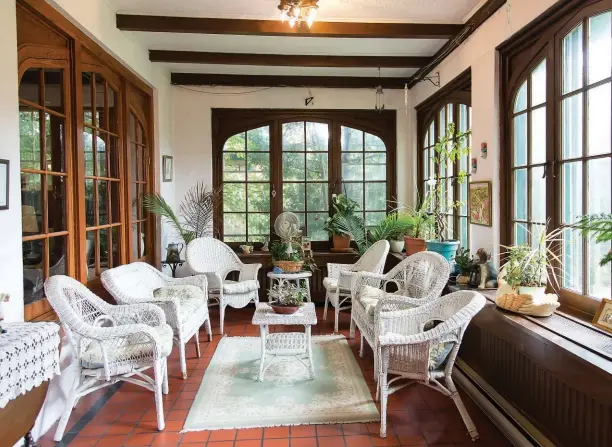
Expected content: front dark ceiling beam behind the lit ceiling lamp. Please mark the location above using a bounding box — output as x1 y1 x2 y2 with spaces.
117 14 462 39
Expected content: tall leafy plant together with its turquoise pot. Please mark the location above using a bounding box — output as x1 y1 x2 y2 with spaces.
426 123 470 261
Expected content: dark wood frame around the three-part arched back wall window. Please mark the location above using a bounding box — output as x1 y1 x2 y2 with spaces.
212 109 397 250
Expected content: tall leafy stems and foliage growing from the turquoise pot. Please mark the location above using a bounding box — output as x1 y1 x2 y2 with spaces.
424 123 471 241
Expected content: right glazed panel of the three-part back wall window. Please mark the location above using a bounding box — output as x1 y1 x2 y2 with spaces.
341 126 388 227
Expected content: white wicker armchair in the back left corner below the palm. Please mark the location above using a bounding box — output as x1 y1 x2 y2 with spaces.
185 237 261 334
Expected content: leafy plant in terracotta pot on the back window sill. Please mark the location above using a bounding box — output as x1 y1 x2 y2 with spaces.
324 194 365 250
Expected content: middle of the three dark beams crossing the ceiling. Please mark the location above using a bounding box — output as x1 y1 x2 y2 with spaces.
149 50 430 68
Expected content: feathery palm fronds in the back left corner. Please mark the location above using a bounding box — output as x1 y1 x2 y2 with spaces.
143 182 221 244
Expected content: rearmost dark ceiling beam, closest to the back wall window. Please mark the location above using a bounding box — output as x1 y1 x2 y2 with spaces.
171 73 406 89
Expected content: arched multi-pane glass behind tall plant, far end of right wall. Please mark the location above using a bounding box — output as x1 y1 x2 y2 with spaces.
420 102 472 247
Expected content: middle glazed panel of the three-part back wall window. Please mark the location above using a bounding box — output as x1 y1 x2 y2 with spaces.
282 121 329 241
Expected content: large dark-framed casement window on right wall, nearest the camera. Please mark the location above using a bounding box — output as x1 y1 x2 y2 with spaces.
501 1 612 314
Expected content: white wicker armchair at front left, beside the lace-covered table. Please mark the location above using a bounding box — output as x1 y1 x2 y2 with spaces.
45 275 172 441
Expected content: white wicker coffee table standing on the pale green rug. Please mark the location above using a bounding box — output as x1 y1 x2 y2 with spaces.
252 303 317 382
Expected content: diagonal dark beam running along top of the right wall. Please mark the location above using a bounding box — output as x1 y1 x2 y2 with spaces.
408 0 506 88
